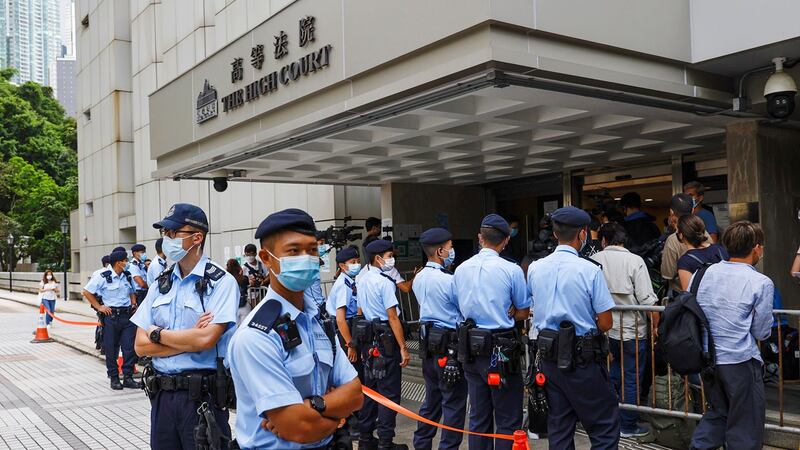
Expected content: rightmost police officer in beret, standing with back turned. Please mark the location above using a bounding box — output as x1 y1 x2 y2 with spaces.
528 206 619 450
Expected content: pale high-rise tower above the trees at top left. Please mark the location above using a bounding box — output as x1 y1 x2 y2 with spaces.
0 0 61 85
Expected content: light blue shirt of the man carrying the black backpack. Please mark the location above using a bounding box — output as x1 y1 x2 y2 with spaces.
692 261 775 364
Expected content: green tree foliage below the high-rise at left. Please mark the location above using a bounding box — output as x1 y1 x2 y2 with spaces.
0 69 78 270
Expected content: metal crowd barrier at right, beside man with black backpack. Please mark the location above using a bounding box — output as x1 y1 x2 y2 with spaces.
607 305 800 435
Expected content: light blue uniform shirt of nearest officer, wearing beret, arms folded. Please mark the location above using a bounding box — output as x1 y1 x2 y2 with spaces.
228 288 358 450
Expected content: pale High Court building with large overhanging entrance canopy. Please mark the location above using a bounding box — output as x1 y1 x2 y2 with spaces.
74 0 800 306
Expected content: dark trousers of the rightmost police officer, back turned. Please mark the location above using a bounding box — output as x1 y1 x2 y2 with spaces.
542 361 619 450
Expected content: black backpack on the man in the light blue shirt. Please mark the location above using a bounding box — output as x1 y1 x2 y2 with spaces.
658 265 716 375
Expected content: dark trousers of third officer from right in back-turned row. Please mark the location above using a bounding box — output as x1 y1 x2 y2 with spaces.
414 356 467 450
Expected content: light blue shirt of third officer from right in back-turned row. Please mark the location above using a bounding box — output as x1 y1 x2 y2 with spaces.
412 262 464 329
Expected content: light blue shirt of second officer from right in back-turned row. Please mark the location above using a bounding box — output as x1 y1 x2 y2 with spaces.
454 248 531 330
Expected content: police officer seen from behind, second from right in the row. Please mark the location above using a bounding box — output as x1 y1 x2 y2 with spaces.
455 214 530 449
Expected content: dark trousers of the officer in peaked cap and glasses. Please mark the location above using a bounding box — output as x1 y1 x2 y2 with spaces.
150 391 231 450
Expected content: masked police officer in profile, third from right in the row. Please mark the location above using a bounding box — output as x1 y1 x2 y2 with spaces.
414 228 467 450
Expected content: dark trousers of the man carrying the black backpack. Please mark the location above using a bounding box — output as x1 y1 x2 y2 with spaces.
692 359 765 450
